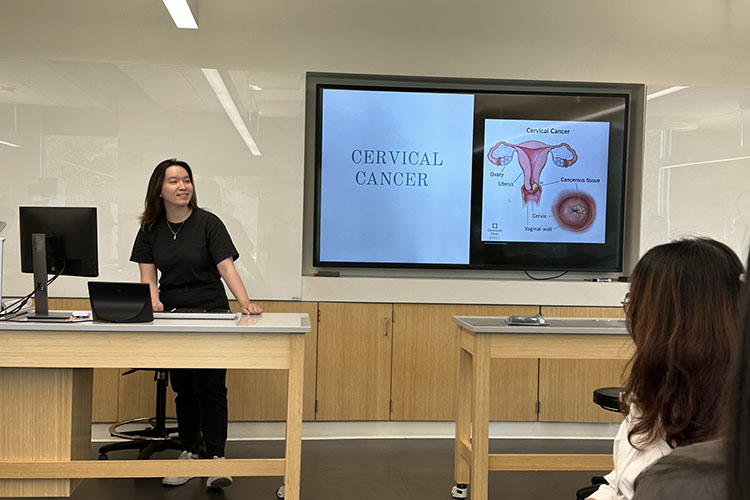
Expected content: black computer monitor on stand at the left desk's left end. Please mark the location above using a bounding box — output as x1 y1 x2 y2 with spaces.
18 207 99 319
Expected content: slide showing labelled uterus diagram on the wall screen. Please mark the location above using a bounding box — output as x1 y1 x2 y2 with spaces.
482 119 609 243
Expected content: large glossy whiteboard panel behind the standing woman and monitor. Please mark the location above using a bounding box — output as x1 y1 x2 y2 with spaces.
0 60 304 299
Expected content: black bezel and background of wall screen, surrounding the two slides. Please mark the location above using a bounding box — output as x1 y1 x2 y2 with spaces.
308 75 632 272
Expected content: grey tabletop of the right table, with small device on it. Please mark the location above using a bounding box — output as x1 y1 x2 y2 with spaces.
453 316 628 335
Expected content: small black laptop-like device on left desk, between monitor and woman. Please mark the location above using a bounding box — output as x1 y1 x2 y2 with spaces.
89 281 154 323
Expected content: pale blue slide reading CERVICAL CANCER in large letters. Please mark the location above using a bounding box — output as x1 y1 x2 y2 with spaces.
319 89 474 264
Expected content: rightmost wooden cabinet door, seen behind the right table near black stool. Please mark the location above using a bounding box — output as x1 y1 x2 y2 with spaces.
539 304 627 422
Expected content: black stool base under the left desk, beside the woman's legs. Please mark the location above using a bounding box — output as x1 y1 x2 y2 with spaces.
99 368 182 460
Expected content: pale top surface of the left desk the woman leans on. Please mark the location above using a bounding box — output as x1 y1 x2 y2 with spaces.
0 313 310 333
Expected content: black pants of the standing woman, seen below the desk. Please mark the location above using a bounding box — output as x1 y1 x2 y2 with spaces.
169 368 228 458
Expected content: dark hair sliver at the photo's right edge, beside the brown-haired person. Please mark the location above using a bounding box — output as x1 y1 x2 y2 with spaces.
727 255 750 500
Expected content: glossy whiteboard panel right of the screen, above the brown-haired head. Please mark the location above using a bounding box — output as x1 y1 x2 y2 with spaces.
641 86 750 262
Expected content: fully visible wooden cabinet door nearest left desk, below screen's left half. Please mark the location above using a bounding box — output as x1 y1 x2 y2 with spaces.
317 302 393 420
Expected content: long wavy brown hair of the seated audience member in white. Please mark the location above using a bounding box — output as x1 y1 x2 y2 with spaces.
623 238 743 447
